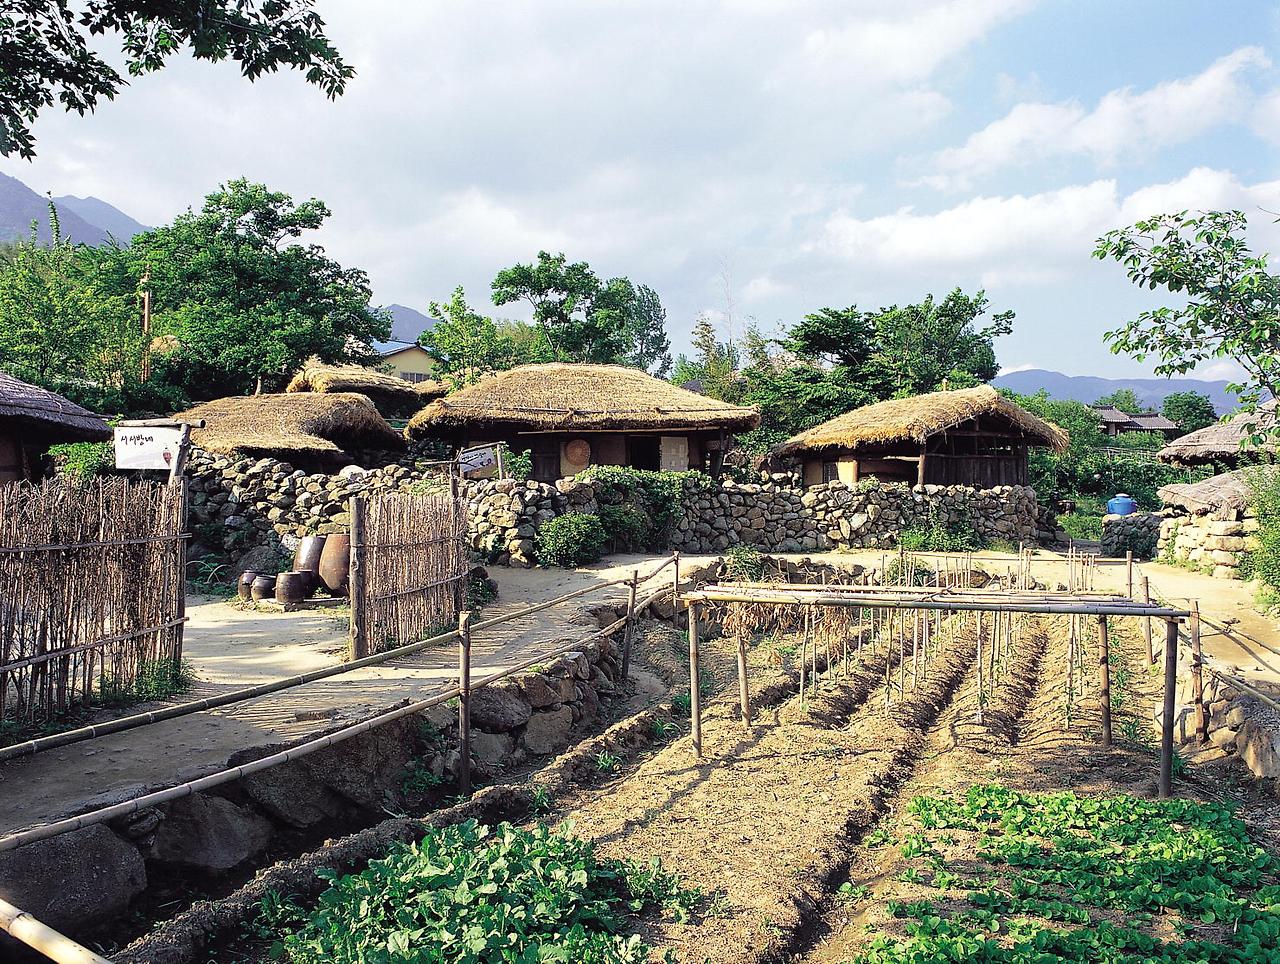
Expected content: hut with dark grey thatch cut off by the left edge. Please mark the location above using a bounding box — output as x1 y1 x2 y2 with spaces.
0 373 111 483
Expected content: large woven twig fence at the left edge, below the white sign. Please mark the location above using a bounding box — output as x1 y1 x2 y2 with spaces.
0 478 184 725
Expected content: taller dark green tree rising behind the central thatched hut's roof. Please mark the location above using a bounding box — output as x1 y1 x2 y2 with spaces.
493 251 671 376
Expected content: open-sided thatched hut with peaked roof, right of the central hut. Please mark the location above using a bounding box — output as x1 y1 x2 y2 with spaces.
773 385 1068 488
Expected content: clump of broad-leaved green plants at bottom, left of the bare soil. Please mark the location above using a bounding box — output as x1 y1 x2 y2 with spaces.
263 821 701 964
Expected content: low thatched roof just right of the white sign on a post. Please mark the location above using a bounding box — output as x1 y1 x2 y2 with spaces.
174 392 404 461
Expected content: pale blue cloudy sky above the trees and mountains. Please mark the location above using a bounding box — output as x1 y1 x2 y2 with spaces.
0 0 1280 378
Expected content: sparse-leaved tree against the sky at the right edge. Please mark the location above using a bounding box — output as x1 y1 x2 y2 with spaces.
1093 211 1280 431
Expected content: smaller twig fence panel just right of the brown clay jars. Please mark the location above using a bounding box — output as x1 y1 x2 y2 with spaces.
351 488 468 659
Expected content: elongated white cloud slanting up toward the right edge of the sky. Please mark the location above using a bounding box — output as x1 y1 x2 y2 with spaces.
925 47 1270 187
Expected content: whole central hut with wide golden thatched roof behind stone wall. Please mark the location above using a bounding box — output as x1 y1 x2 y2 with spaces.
407 362 760 481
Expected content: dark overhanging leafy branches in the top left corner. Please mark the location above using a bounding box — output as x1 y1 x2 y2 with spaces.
0 0 355 157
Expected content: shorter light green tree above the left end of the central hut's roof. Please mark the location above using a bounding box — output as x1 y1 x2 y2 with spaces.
419 287 549 385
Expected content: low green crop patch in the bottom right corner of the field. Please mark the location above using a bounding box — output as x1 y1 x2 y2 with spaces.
856 785 1280 964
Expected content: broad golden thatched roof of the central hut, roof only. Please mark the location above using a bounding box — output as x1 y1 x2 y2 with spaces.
408 362 760 437
